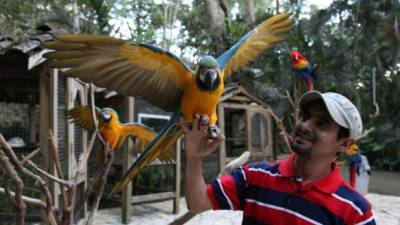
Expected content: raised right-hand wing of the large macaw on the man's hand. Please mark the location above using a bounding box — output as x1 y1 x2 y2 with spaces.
217 13 292 77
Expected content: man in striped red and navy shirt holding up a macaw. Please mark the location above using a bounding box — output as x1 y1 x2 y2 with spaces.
181 91 375 225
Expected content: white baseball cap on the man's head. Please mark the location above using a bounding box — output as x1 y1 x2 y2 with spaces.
299 91 363 140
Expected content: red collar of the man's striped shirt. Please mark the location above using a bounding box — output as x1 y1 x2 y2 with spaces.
279 153 343 194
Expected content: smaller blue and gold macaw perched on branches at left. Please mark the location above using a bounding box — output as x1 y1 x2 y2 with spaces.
67 106 175 163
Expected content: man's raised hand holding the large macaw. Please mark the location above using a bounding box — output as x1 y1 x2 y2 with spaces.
179 114 225 159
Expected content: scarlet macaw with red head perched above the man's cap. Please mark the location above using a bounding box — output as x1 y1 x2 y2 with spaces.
290 51 315 91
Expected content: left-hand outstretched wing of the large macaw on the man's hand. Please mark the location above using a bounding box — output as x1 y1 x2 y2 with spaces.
43 34 193 111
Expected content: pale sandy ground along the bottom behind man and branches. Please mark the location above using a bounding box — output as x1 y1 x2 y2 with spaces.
90 193 400 225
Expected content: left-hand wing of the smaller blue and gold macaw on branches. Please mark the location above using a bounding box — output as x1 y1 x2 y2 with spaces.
66 106 100 131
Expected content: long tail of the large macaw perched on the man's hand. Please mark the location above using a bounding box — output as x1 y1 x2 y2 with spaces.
110 112 182 195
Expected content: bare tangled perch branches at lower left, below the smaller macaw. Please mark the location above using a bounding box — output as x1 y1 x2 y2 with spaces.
0 82 114 225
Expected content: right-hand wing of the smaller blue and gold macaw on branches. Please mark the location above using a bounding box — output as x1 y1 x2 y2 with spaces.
120 123 176 163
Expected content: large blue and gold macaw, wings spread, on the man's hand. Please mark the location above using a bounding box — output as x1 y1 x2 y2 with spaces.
44 14 292 193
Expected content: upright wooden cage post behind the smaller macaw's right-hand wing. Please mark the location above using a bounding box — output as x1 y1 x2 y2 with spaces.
121 97 134 224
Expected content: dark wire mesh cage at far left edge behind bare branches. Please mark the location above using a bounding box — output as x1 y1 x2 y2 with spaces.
0 48 40 224
